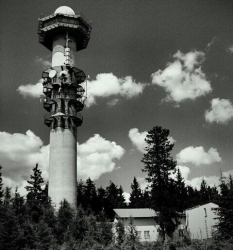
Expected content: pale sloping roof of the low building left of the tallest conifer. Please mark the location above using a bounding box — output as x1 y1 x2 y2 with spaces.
113 208 156 218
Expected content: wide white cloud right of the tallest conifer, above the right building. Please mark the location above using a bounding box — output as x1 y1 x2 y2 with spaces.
176 146 222 166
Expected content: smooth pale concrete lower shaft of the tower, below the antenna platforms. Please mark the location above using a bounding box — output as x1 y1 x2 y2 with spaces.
49 127 77 207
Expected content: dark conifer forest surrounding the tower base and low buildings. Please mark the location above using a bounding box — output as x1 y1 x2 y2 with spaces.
0 126 233 250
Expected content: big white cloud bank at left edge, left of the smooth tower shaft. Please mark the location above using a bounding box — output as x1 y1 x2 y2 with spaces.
0 130 49 186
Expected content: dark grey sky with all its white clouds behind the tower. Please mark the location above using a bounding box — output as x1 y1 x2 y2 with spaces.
0 0 233 201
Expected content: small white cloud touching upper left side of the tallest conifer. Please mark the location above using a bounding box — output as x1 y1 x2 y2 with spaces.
129 128 148 153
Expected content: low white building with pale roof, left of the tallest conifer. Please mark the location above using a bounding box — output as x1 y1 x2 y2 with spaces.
113 208 159 242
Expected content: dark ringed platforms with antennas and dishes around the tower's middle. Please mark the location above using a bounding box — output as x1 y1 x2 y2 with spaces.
42 65 86 128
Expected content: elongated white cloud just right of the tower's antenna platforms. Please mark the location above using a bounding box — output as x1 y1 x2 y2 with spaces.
86 73 146 107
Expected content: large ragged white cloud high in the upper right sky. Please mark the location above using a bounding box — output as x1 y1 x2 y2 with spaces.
152 51 212 103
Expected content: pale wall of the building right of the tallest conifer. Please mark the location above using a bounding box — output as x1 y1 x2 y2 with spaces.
186 203 218 239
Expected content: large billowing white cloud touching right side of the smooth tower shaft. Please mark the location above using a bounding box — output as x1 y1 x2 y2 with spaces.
77 134 124 180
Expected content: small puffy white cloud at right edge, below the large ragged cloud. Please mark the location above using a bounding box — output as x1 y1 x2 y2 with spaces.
205 98 233 124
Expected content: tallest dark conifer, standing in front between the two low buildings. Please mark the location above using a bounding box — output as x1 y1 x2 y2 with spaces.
142 126 179 241
